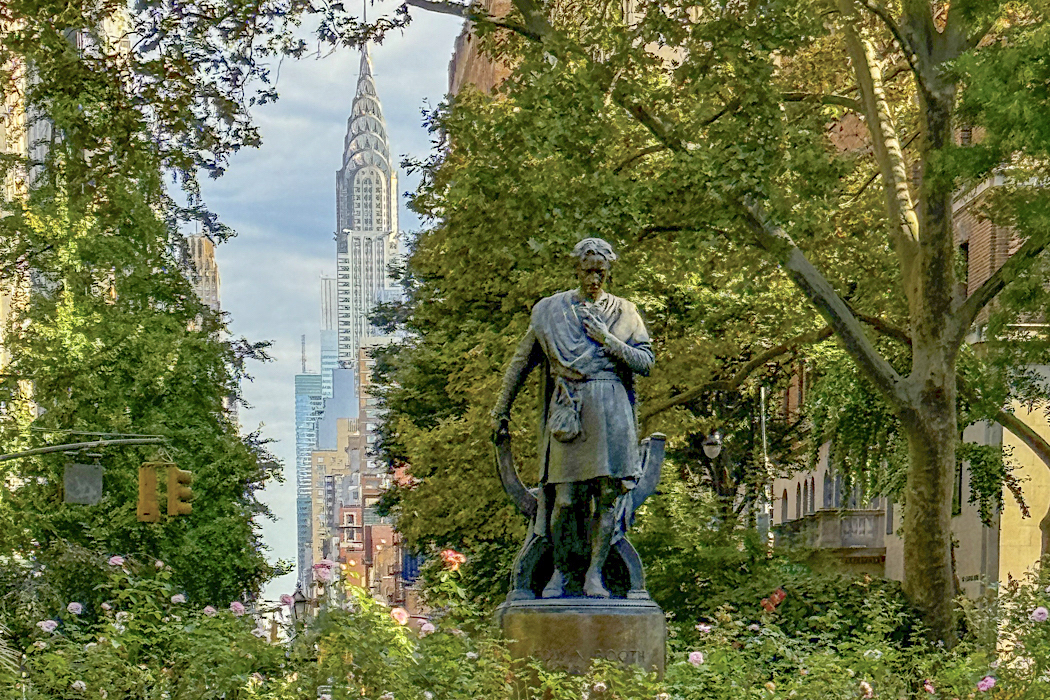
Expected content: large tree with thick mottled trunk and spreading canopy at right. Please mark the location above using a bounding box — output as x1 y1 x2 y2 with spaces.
392 0 1050 643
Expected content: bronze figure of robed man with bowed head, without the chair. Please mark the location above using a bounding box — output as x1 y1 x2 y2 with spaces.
492 238 653 598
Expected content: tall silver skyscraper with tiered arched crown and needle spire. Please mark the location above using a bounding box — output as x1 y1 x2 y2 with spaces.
335 45 399 367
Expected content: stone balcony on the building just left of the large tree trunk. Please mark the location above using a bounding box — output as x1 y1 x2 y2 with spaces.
773 508 886 576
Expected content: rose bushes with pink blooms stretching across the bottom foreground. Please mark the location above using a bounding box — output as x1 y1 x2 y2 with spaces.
10 560 1050 700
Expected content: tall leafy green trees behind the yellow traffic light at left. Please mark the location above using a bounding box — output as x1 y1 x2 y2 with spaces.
0 0 295 601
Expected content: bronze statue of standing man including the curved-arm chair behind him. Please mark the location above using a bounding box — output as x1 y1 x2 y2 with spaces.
492 238 664 599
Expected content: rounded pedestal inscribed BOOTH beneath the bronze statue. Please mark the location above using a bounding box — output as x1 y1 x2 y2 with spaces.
496 598 667 676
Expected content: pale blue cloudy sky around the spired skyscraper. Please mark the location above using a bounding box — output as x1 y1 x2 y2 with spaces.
204 2 462 599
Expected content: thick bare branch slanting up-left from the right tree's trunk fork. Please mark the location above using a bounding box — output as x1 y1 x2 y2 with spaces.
739 203 909 408
